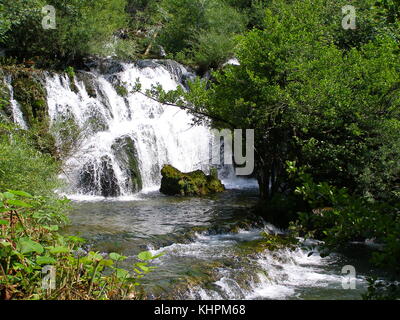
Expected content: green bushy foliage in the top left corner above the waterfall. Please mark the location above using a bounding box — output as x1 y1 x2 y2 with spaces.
3 0 127 65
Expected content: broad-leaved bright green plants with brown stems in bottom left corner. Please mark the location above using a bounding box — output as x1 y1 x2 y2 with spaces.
0 190 162 300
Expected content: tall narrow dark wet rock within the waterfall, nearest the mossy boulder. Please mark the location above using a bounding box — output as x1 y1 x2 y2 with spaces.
111 136 143 192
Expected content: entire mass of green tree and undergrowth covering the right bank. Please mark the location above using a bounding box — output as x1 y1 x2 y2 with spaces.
147 0 400 300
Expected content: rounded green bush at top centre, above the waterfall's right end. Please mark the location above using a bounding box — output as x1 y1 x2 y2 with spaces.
158 0 247 70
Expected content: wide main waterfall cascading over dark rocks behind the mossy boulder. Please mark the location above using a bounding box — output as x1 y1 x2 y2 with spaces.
46 61 211 196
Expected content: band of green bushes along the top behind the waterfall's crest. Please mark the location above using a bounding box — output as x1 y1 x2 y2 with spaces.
0 0 265 72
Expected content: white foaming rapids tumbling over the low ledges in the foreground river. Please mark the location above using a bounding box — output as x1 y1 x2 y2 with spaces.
149 225 366 300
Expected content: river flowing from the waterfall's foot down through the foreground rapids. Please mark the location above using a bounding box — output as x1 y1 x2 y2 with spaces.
65 188 384 299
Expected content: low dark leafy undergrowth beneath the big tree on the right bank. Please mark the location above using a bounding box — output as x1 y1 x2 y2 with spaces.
288 162 400 272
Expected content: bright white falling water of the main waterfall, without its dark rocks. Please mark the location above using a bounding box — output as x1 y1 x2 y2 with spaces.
46 59 216 196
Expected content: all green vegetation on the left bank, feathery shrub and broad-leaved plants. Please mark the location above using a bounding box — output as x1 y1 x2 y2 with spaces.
0 124 161 300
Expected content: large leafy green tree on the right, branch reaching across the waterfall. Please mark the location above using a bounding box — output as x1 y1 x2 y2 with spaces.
147 0 400 199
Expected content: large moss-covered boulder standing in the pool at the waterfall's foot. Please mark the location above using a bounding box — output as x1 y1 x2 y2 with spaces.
160 165 225 196
